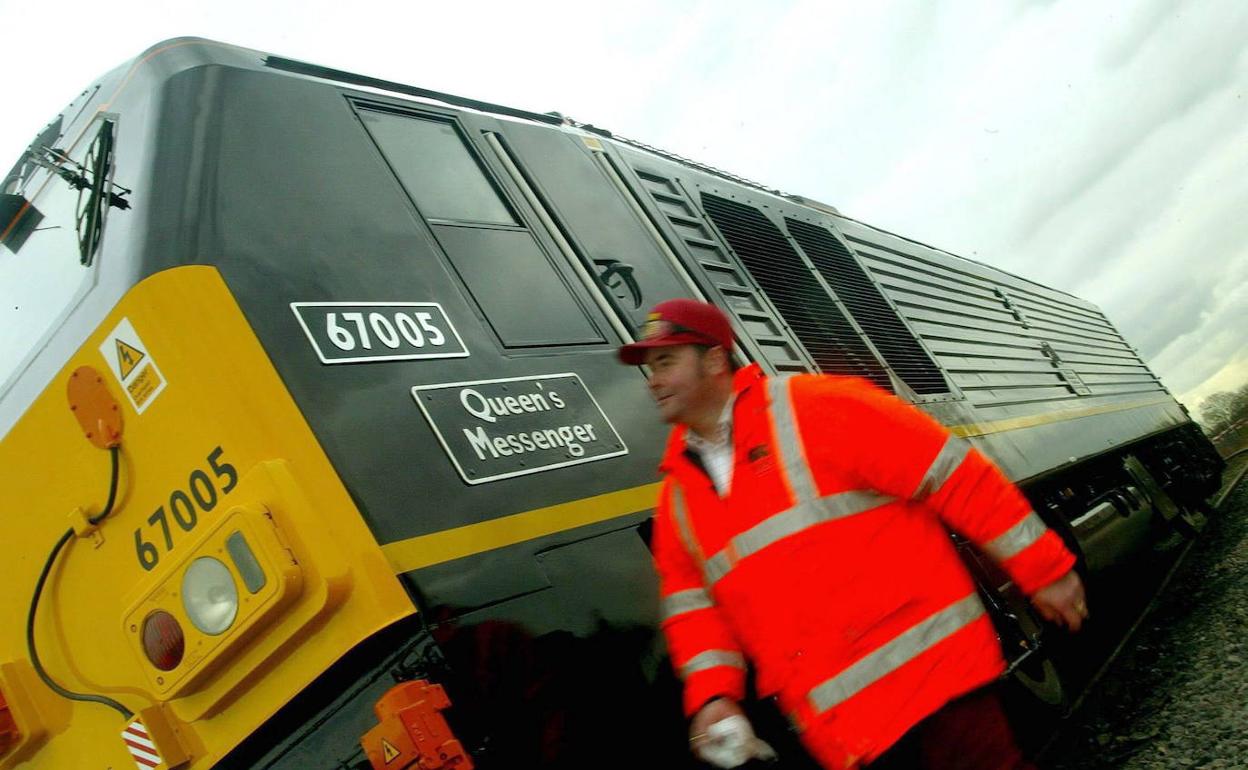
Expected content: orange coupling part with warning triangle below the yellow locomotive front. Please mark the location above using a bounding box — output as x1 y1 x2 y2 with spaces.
359 679 473 770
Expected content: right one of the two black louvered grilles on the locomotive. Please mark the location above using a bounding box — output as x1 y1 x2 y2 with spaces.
785 218 948 396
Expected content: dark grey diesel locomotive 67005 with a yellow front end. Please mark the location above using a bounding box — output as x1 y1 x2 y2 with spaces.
0 39 1221 770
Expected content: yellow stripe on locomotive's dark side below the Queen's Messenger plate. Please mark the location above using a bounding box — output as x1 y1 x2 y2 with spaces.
382 483 659 574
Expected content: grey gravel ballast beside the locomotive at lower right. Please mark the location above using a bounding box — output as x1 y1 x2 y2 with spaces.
1040 449 1248 770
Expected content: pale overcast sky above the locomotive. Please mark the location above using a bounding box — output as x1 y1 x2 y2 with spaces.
0 0 1248 409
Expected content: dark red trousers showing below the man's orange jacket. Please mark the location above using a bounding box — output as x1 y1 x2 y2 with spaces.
867 688 1036 770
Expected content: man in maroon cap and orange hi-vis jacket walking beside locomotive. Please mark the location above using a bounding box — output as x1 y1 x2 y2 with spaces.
619 300 1087 770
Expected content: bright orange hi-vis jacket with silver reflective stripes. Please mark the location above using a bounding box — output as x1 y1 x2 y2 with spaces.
654 366 1075 768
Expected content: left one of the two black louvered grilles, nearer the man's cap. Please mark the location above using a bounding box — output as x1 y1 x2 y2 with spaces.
701 192 892 391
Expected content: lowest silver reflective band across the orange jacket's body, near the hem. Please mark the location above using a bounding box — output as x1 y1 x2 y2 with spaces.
807 594 983 714
